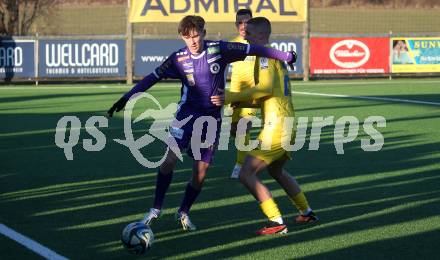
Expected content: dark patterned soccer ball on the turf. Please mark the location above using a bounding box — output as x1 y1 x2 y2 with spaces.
121 222 154 255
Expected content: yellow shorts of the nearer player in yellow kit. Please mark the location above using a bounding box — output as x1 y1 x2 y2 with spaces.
249 126 296 165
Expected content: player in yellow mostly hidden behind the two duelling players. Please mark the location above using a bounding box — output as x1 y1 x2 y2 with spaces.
229 9 256 179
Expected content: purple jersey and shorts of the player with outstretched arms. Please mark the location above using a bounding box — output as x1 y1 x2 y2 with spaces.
124 41 293 163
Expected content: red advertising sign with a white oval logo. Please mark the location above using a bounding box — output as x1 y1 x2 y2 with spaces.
310 37 390 74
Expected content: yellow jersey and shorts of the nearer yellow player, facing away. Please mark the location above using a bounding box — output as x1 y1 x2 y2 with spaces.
225 53 295 164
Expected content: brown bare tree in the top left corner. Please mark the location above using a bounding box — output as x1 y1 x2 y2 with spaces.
0 0 58 36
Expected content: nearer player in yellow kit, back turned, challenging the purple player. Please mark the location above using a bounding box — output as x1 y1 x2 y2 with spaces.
211 17 318 235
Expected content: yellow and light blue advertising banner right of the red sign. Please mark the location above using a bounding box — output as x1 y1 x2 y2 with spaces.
390 37 440 73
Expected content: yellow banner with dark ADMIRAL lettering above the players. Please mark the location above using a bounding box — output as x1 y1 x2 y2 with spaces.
129 0 307 23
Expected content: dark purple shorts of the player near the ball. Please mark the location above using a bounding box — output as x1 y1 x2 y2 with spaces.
170 104 222 163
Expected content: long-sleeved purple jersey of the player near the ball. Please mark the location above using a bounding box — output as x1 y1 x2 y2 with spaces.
125 40 292 110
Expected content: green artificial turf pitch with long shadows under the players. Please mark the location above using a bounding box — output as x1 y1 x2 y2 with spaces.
0 79 440 259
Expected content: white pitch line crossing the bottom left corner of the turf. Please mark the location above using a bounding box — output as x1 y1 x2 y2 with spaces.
0 223 68 260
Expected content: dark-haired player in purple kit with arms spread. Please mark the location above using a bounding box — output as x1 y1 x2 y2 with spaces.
107 15 296 231
